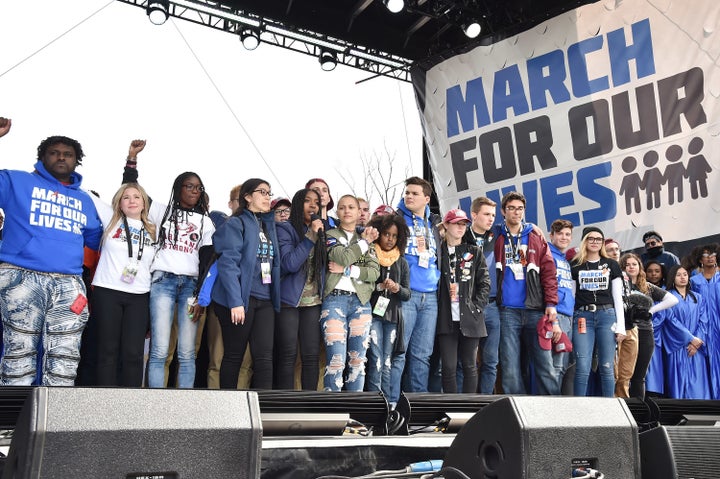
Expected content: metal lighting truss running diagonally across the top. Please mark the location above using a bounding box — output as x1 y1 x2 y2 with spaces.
118 0 412 82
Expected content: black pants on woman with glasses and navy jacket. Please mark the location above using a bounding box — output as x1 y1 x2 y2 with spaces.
213 297 275 389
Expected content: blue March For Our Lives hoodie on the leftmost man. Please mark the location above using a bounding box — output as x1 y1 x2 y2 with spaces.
0 161 103 275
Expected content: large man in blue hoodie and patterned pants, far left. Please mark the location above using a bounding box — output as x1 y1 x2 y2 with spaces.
0 118 103 386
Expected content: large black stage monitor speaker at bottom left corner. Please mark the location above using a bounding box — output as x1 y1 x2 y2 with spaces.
3 387 262 479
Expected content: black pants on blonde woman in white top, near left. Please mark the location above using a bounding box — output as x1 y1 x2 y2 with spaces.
92 287 150 387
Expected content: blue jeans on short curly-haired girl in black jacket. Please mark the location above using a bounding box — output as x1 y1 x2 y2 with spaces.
365 316 397 398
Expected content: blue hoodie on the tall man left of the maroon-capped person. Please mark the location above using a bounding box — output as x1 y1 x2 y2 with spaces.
398 200 440 293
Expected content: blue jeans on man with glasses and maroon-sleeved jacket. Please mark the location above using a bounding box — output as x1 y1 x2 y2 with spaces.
500 308 560 395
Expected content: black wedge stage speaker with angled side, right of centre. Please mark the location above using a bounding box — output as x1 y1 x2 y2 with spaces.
443 396 640 479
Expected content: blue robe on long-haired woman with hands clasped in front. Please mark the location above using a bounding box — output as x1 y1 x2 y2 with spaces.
661 290 711 399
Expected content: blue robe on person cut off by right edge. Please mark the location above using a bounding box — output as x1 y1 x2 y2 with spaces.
690 273 720 399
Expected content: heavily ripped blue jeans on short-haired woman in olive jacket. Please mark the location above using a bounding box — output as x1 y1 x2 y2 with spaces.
320 290 372 391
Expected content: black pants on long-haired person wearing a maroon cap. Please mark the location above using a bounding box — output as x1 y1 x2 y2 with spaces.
437 330 480 393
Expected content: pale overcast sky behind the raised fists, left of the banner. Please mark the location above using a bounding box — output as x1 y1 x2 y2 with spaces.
0 0 422 210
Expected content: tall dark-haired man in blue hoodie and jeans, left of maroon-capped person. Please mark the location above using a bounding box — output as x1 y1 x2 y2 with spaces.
389 176 440 404
